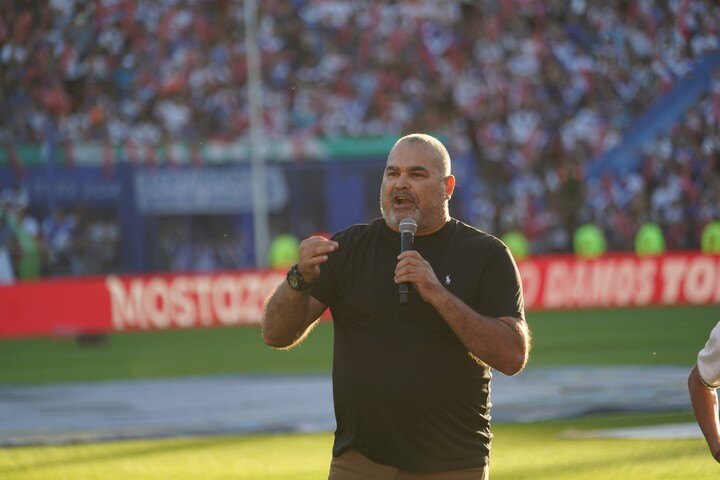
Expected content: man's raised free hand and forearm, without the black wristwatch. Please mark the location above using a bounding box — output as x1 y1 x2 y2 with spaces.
261 237 338 348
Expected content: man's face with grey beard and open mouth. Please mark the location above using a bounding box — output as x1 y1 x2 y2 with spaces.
380 142 455 235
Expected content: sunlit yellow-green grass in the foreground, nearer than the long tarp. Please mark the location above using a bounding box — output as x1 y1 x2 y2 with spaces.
0 413 720 480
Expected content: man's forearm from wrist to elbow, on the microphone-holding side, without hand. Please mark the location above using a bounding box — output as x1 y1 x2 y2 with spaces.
431 290 530 375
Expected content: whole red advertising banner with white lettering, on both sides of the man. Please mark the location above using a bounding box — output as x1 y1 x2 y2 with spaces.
0 253 720 338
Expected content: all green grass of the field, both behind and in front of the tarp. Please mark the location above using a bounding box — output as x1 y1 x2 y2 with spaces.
0 306 720 480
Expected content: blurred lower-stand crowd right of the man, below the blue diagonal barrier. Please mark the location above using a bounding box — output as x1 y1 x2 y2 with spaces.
470 71 720 253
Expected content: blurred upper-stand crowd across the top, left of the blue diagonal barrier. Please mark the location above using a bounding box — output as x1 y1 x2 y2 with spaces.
0 0 720 145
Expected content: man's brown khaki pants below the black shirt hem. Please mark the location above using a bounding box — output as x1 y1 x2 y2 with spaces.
328 450 490 480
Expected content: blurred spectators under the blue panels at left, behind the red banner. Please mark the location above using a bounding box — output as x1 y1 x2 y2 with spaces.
0 187 254 285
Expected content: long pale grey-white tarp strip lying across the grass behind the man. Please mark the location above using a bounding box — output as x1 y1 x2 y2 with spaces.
0 366 690 446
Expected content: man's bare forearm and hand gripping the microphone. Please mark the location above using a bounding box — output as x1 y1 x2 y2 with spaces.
395 251 530 375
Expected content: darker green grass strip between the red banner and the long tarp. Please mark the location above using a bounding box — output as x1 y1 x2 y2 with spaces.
0 305 720 384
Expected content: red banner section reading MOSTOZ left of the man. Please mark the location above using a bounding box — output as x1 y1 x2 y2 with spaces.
0 270 285 338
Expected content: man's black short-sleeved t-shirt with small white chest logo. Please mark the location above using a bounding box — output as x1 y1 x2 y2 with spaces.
311 219 524 472
